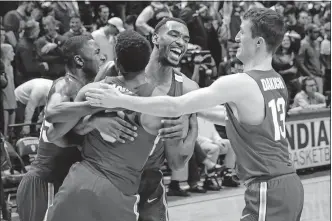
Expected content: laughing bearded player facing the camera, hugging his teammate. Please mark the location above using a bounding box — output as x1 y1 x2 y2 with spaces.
91 18 223 221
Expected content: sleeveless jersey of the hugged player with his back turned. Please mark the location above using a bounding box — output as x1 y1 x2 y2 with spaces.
82 77 156 195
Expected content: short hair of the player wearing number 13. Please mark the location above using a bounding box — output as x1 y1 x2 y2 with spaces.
243 8 285 53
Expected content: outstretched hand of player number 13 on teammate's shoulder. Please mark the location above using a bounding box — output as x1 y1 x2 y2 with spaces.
85 83 122 108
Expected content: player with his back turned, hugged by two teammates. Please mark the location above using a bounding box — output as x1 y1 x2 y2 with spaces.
46 31 197 221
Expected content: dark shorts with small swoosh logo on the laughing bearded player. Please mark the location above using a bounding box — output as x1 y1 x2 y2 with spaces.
138 170 169 221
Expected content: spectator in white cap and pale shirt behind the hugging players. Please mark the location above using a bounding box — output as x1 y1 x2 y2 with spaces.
92 17 125 61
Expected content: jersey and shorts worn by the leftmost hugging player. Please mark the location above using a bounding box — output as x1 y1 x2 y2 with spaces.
17 77 81 221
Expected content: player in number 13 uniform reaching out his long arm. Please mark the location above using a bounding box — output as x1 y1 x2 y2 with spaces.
86 8 304 221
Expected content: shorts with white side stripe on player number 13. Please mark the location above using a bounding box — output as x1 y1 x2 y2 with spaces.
240 173 304 221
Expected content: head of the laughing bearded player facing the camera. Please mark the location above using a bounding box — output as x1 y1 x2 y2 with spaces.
152 17 189 66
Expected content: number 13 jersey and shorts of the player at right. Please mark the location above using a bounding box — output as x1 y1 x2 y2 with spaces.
225 70 304 221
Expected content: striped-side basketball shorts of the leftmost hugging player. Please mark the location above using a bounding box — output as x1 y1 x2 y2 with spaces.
16 173 54 221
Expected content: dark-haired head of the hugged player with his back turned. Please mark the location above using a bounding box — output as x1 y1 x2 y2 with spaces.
115 30 151 80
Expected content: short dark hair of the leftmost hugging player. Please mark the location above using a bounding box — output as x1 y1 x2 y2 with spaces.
61 35 93 67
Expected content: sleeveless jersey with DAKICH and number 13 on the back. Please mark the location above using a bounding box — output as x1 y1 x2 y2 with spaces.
225 70 295 181
